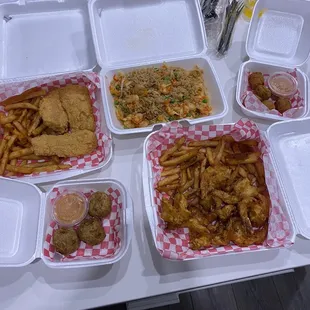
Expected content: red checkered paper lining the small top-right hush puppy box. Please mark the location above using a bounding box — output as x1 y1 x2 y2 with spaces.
241 70 304 118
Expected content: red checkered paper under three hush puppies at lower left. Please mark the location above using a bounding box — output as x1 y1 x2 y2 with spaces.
43 187 123 262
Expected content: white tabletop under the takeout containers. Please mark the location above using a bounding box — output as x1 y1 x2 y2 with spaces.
0 22 310 310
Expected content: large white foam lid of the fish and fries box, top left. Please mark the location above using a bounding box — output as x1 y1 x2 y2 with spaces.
0 0 97 79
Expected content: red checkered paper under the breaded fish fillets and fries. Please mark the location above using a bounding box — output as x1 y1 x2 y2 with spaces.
0 72 112 179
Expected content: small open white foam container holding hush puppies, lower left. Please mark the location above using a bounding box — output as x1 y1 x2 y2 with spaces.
0 178 133 268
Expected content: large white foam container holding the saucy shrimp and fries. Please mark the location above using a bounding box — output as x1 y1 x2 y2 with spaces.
142 122 310 260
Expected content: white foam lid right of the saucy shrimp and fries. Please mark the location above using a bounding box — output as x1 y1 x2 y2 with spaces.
267 118 310 239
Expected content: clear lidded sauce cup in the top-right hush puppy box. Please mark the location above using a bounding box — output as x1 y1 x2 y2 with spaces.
268 72 298 97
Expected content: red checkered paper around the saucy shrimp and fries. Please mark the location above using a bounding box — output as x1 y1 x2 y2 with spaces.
146 119 294 260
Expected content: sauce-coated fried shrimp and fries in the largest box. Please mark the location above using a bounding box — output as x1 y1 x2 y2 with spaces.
157 136 270 250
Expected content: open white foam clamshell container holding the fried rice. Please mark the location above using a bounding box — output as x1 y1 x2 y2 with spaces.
89 0 228 135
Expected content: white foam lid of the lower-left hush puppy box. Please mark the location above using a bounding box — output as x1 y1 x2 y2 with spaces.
0 178 45 267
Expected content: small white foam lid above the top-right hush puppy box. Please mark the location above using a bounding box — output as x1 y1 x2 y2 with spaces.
246 0 310 67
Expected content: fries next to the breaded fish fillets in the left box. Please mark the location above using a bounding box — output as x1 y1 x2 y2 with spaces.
0 88 72 177
